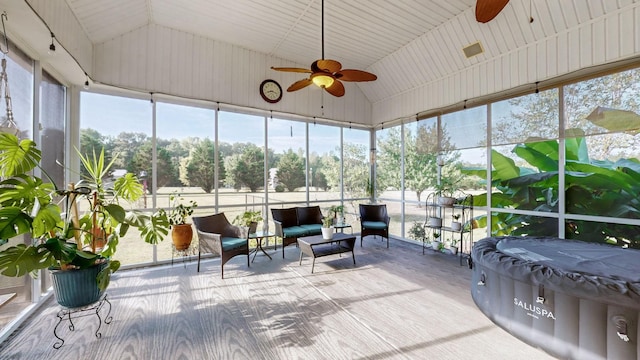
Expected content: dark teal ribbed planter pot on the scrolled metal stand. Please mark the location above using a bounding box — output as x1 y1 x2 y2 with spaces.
49 262 109 308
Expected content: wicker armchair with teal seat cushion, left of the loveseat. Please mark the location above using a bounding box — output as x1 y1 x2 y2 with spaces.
192 213 249 279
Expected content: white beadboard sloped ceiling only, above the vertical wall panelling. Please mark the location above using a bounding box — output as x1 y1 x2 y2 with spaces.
61 0 637 107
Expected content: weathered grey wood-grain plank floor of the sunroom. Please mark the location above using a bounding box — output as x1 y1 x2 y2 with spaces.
0 238 552 360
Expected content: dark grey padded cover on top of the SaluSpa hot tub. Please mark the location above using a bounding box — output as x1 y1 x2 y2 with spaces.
472 236 640 309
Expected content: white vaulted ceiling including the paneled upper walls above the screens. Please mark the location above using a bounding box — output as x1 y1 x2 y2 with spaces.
0 0 640 125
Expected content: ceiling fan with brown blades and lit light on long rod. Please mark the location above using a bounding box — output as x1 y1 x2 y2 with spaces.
271 0 378 97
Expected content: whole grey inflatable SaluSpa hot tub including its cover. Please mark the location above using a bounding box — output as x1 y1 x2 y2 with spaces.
471 237 640 360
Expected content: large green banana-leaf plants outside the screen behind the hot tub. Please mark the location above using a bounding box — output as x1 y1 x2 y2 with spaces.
463 137 640 248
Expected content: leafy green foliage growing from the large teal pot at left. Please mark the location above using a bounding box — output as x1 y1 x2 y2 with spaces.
0 133 169 290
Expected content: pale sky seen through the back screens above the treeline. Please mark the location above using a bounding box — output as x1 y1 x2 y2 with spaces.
80 92 369 154
